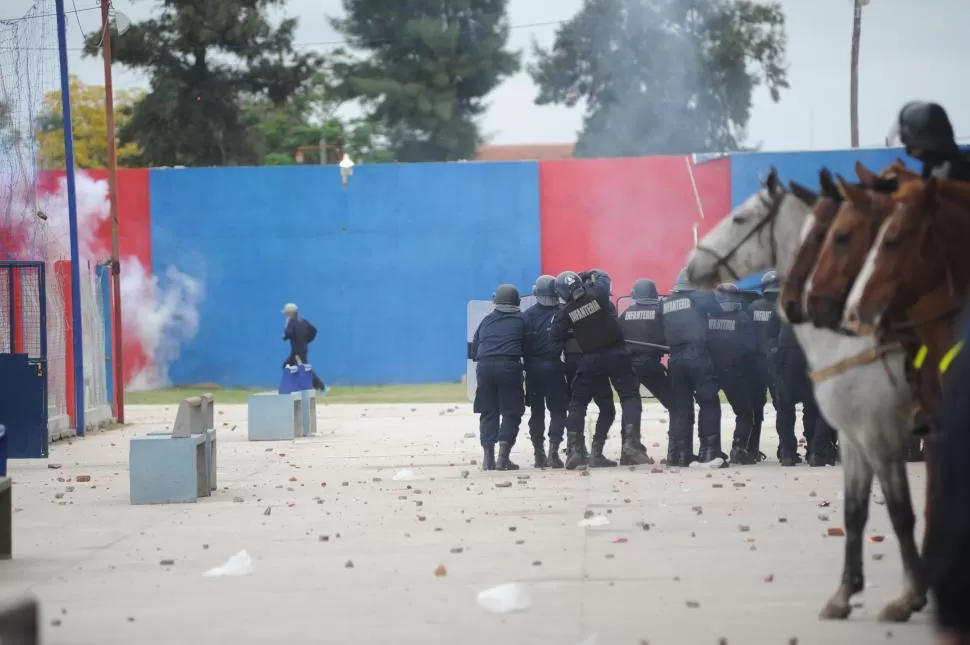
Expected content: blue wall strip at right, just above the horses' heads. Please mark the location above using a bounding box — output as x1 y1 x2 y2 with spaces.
731 148 916 206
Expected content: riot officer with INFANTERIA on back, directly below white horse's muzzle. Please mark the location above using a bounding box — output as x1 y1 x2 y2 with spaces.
663 270 726 466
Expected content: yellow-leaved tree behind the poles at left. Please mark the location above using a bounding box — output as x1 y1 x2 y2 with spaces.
36 76 141 169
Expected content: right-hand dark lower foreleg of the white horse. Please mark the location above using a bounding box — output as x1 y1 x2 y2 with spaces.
864 455 926 623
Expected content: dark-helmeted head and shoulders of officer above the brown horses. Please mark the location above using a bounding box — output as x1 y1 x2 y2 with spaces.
891 101 970 181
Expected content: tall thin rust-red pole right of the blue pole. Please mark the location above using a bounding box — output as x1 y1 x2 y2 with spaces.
101 0 125 423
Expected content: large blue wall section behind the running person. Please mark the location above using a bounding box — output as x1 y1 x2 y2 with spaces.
151 163 540 386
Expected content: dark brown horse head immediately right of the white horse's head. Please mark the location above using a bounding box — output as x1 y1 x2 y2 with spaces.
778 168 843 325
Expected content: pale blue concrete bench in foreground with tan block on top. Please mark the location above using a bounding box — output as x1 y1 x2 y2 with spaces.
128 394 218 504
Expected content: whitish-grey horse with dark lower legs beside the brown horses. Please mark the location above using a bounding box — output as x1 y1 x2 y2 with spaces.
687 169 926 622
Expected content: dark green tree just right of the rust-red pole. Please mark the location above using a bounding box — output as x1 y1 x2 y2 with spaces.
85 0 321 166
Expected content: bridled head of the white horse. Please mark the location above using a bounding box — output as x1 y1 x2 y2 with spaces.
687 169 811 288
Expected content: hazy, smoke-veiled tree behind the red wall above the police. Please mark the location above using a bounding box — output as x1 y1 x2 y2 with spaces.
529 0 788 157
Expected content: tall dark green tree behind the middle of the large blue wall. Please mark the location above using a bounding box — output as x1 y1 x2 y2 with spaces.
331 0 519 161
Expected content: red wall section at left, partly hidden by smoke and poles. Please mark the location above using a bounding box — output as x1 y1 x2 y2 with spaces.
38 168 152 383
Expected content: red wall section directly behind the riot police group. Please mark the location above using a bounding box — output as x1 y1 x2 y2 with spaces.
539 157 731 296
